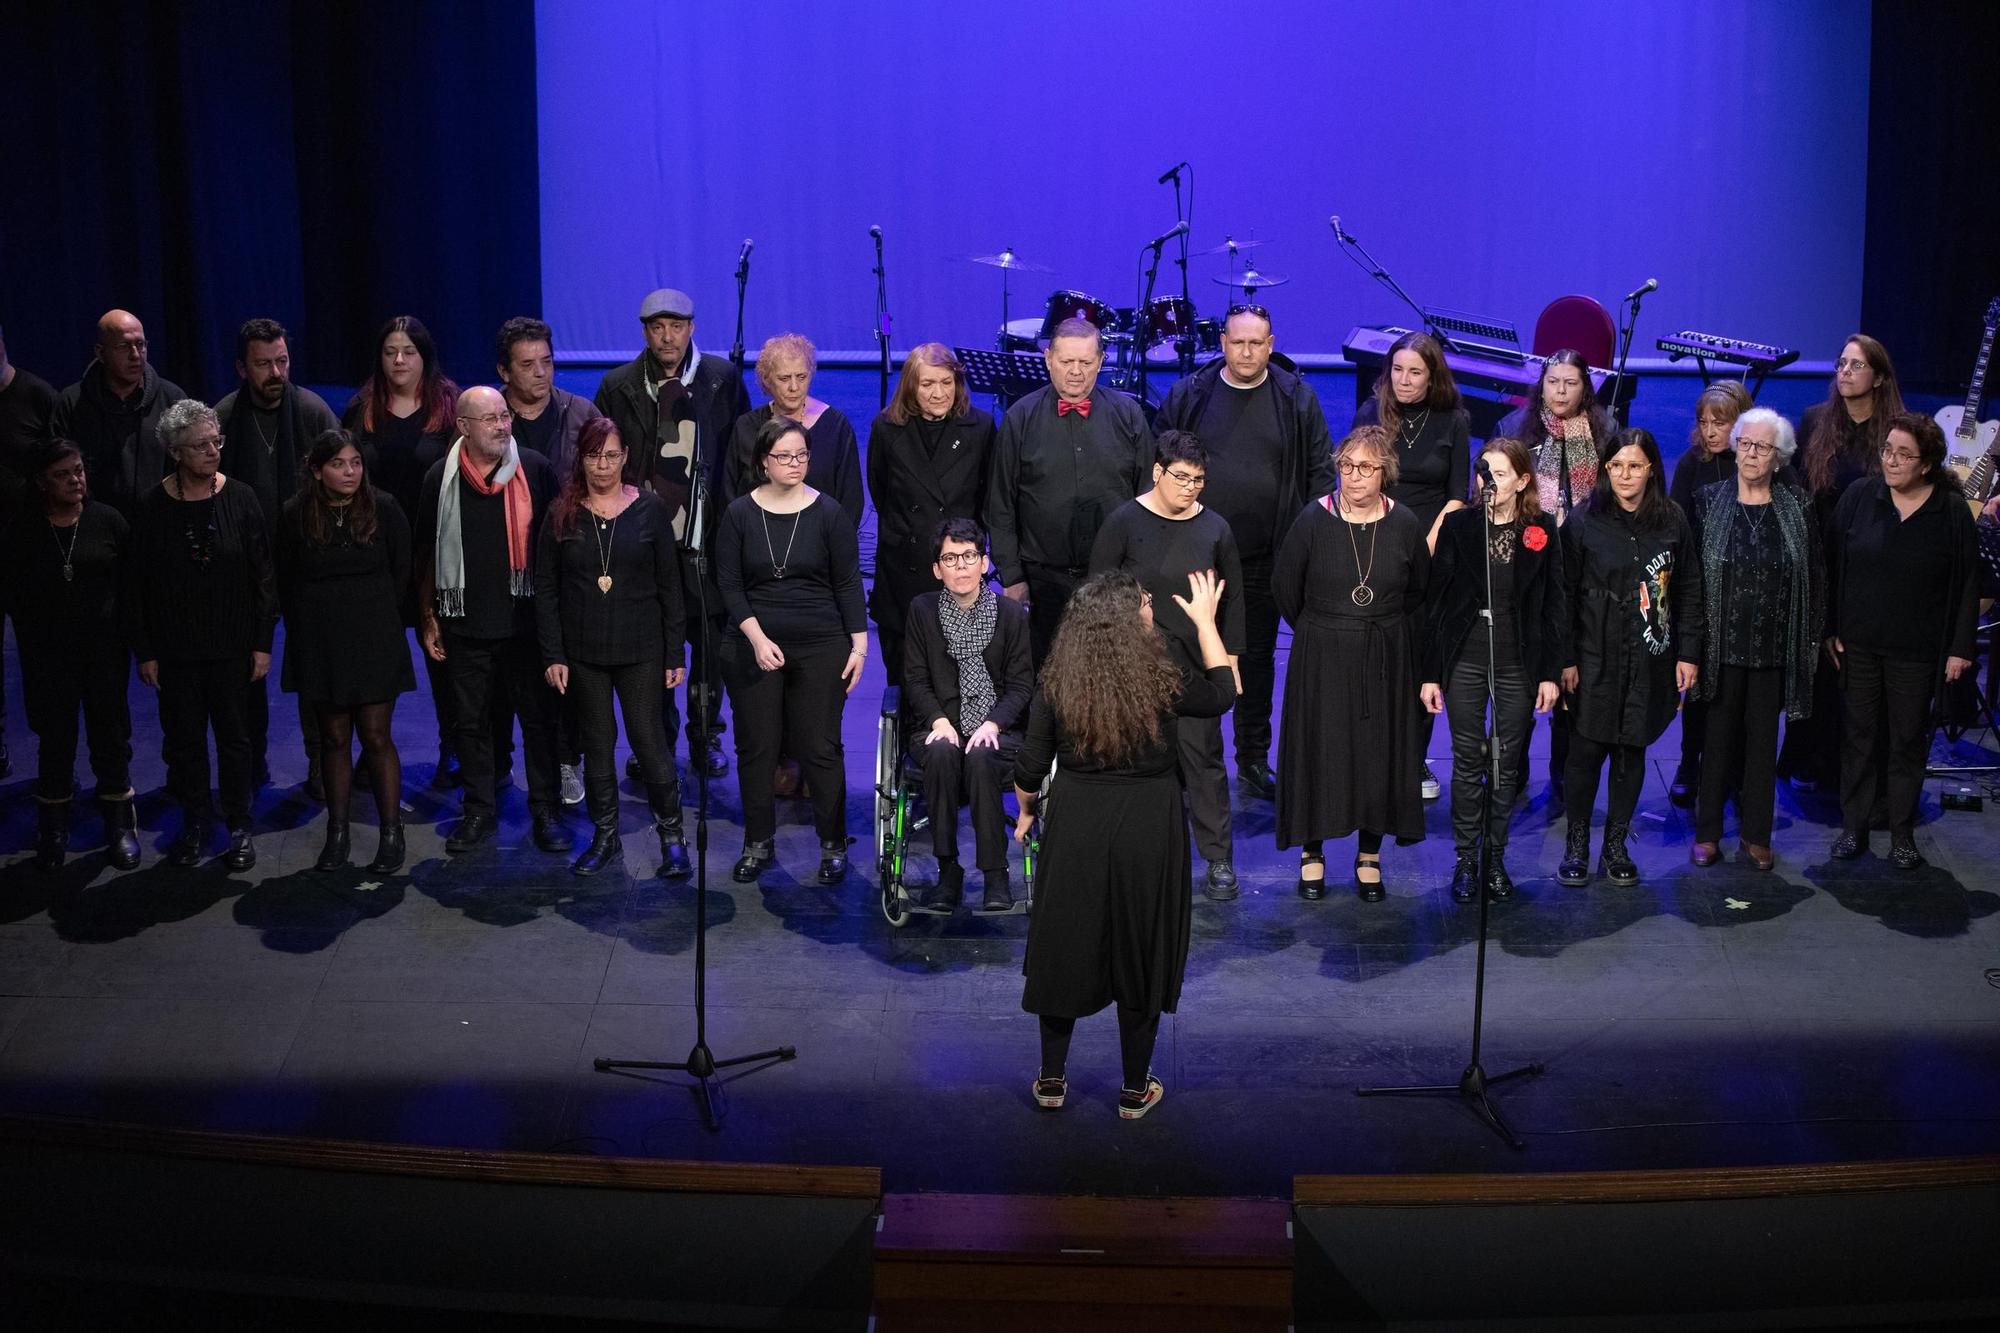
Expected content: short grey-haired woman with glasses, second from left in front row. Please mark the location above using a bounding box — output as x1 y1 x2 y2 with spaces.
126 398 278 871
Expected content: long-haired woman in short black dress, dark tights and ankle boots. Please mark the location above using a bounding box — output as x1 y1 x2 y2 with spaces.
276 430 416 875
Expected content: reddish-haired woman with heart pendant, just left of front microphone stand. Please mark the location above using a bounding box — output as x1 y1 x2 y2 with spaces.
534 416 694 879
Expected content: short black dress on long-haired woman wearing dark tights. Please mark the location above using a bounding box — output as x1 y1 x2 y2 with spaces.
276 490 416 709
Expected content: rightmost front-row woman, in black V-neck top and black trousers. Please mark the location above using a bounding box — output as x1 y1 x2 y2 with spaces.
1826 412 1980 871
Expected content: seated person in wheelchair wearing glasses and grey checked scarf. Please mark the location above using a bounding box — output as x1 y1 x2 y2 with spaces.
902 518 1034 913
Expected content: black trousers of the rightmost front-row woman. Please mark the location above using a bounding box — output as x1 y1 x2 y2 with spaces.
1840 646 1938 837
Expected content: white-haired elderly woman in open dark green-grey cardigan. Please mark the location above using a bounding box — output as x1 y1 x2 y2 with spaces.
1690 408 1826 871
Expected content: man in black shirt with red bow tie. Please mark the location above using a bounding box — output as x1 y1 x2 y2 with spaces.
986 320 1152 669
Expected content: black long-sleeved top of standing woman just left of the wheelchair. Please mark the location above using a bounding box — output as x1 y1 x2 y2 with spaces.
716 494 868 644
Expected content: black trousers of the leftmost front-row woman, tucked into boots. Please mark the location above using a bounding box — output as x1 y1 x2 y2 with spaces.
20 642 131 801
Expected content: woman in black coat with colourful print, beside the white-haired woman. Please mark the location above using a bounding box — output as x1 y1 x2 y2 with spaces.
1556 428 1702 889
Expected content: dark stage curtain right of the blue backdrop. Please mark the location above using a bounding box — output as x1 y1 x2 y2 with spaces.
1856 0 2000 392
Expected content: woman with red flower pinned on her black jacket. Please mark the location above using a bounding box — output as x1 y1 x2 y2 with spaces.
1422 438 1570 903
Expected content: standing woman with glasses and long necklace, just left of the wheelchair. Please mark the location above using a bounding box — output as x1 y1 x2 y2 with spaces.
716 416 868 885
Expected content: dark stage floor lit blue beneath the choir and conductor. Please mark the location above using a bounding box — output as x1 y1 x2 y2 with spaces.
0 632 2000 1195
